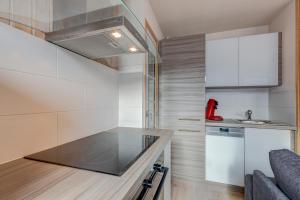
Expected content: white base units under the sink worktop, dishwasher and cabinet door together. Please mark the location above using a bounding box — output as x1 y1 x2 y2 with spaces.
205 127 295 186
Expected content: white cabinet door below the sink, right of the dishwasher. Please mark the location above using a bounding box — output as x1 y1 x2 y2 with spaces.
245 128 291 177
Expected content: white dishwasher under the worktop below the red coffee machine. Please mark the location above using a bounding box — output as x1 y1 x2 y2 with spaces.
205 127 245 186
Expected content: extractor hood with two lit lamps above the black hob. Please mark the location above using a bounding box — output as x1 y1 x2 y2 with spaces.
45 6 148 60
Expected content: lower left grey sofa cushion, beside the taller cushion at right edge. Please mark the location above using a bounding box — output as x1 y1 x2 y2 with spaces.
253 170 289 200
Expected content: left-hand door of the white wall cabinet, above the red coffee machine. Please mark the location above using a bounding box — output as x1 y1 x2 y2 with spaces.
206 38 238 87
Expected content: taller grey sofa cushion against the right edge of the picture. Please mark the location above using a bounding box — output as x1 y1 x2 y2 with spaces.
269 149 300 200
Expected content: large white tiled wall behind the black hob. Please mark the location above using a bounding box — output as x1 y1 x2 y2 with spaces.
0 23 118 163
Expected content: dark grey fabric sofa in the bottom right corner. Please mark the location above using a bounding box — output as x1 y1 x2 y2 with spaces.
245 149 300 200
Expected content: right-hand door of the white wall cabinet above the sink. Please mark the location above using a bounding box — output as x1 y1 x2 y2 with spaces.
239 33 279 86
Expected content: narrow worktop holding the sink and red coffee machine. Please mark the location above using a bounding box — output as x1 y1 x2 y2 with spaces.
205 119 296 131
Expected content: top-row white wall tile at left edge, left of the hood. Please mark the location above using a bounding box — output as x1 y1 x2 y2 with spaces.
0 24 57 77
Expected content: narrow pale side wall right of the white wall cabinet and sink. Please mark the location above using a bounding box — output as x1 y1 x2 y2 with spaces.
269 0 296 125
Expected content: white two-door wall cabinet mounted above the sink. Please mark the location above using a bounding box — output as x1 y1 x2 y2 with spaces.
206 33 281 87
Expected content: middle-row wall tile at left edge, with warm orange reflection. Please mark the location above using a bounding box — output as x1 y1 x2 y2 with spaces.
0 70 84 115
